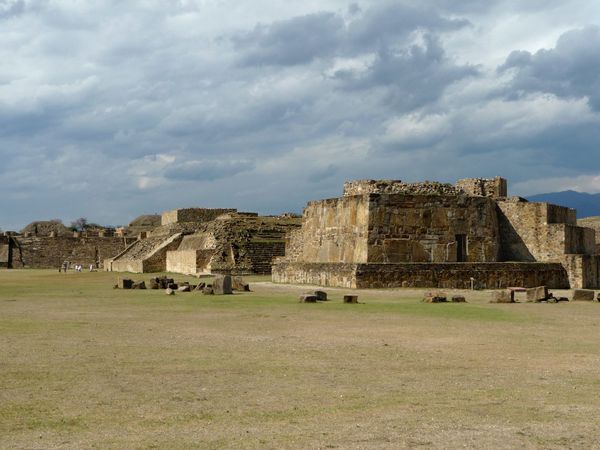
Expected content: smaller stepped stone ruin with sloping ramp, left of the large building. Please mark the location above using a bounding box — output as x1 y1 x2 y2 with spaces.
104 208 300 275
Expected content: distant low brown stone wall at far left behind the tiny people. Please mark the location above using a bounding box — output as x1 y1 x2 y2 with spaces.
12 236 133 269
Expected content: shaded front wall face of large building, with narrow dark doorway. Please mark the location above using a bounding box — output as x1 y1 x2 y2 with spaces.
366 194 499 263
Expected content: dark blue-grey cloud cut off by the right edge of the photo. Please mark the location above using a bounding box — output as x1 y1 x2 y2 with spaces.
499 26 600 111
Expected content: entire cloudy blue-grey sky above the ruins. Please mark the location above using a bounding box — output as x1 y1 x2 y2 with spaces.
0 0 600 230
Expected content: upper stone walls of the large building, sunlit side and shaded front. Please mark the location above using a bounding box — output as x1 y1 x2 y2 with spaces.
285 194 499 263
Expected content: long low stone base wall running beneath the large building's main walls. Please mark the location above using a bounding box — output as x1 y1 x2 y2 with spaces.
273 262 569 289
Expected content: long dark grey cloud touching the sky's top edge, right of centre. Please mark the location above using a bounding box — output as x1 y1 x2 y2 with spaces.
233 1 469 66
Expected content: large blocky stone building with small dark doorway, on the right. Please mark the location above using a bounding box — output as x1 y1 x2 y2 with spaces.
273 177 600 288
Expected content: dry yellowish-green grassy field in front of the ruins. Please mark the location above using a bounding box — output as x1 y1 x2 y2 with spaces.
0 271 600 449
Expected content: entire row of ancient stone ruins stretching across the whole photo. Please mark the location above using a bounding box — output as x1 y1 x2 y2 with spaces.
0 177 600 289
